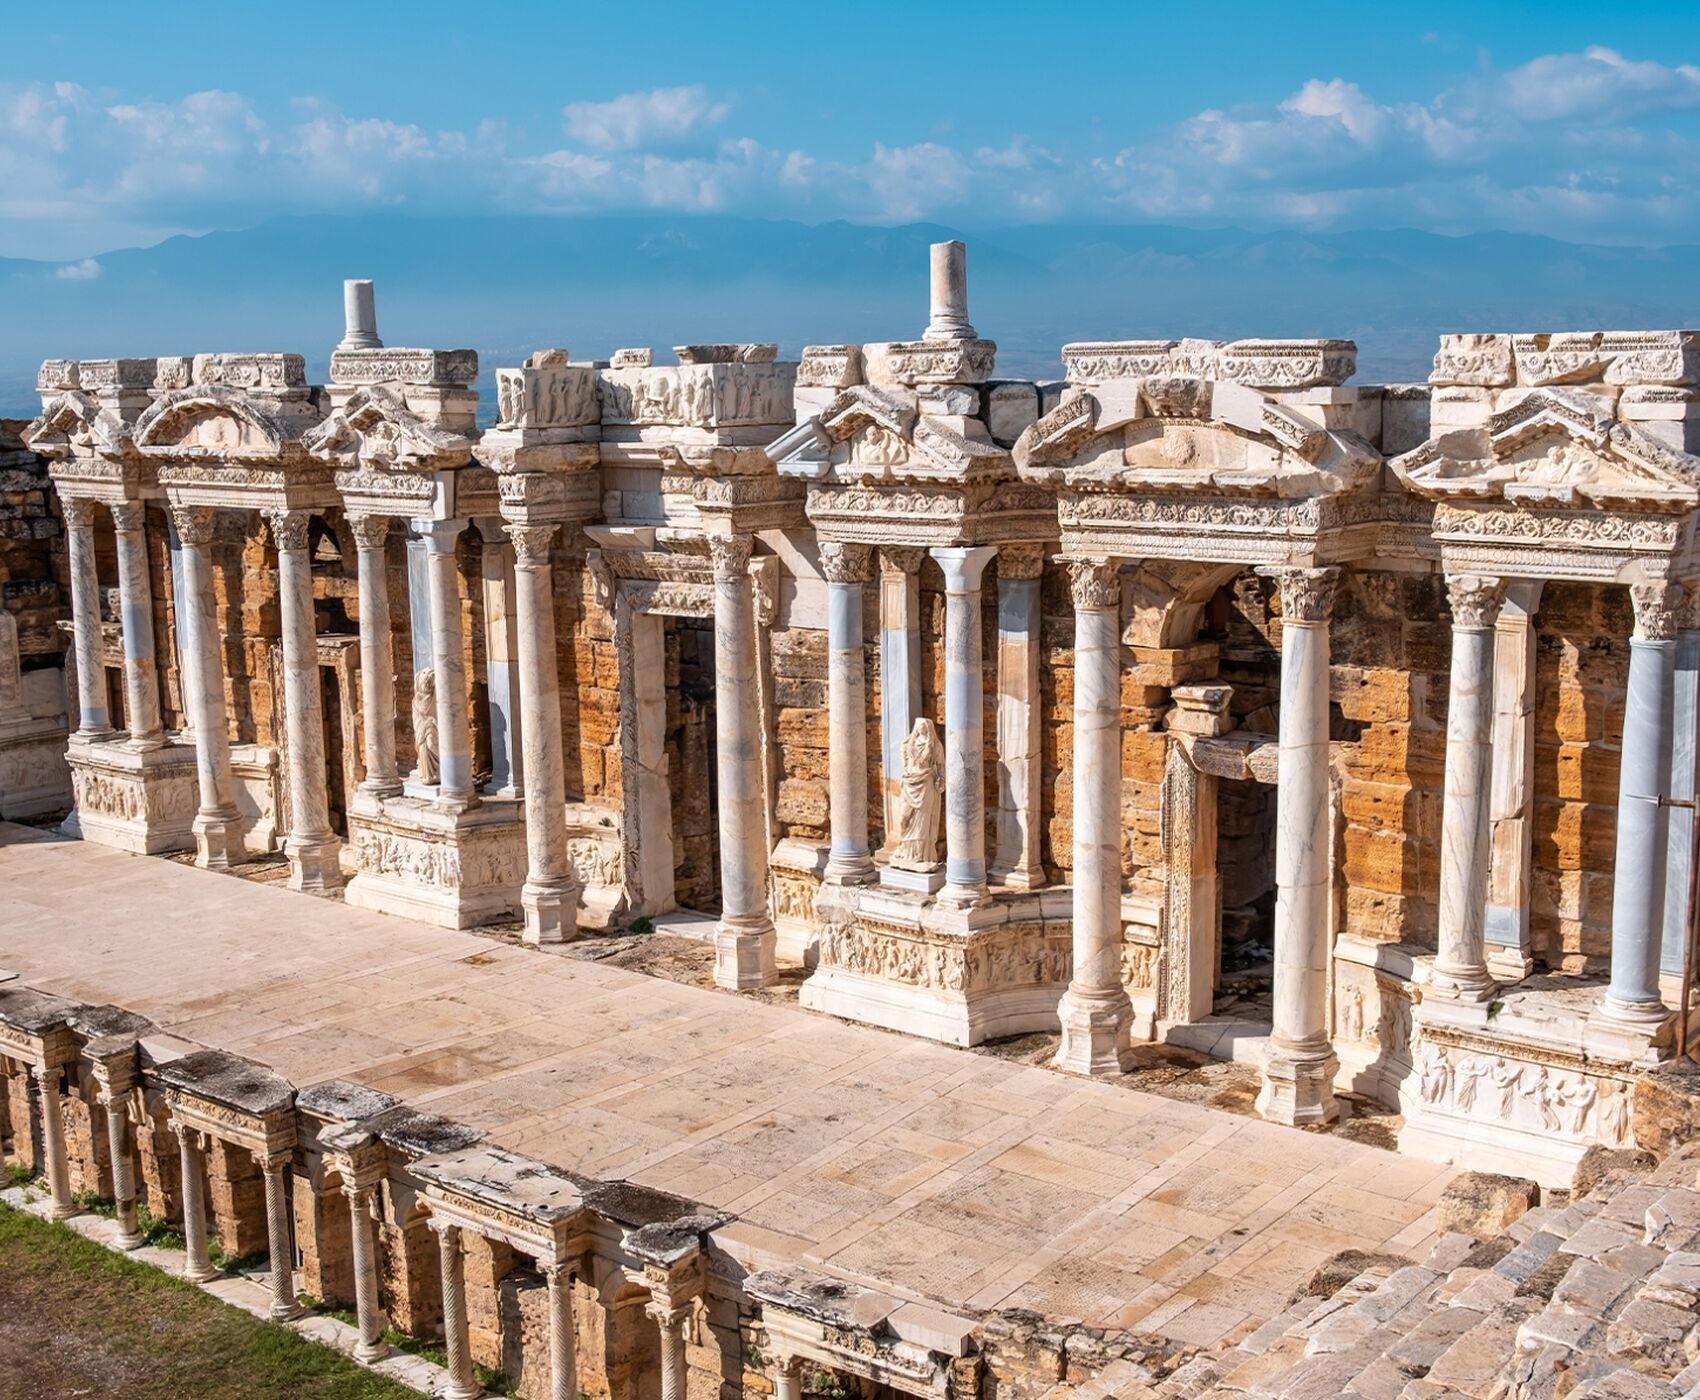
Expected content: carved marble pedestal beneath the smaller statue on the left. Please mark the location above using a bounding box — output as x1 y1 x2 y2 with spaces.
345 795 525 928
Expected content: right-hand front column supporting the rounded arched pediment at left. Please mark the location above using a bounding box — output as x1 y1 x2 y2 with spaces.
265 510 342 894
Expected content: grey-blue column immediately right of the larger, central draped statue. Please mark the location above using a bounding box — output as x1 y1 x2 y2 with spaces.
932 545 998 909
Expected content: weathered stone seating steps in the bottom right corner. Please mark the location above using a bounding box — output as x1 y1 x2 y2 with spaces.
1071 1145 1700 1400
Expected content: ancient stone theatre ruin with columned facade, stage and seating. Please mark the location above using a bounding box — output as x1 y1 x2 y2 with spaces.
0 243 1700 1400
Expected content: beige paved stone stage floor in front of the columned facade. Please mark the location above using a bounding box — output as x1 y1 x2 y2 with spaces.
0 824 1454 1344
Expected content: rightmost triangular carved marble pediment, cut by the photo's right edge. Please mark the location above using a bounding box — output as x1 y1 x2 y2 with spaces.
1391 389 1700 511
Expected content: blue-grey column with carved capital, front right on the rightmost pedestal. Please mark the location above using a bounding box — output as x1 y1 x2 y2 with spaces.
1598 581 1681 1030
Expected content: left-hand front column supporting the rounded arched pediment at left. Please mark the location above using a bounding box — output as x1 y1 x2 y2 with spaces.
172 506 243 870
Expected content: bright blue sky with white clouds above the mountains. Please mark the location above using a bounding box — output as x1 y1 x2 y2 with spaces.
0 0 1700 261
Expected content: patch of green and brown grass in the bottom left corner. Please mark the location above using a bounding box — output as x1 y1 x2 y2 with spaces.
0 1206 418 1400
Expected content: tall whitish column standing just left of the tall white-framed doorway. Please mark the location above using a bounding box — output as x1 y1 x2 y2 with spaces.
508 525 580 943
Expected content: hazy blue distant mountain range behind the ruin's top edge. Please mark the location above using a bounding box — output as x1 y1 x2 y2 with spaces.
0 214 1700 416
